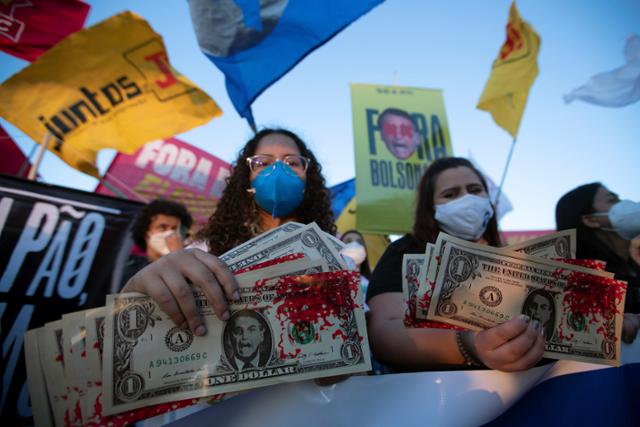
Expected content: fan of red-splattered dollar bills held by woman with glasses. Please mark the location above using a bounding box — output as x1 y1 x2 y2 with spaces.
25 222 371 426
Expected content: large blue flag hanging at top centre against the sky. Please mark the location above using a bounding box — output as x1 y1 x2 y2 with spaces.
189 0 383 129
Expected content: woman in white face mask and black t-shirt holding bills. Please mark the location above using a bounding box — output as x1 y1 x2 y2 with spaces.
367 157 544 371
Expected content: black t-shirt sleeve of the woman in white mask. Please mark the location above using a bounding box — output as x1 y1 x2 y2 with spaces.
367 235 425 302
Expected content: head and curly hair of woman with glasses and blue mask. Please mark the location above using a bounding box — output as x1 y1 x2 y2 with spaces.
198 129 336 255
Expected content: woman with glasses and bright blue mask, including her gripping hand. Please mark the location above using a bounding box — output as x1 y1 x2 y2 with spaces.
122 129 336 335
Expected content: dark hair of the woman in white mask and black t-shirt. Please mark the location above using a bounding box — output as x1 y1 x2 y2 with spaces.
410 157 502 248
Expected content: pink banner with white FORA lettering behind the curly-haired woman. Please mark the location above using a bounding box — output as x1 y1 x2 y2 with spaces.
96 138 231 225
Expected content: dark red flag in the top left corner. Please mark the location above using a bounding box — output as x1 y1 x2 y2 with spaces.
0 0 90 62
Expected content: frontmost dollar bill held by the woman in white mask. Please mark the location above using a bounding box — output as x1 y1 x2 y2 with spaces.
427 235 626 365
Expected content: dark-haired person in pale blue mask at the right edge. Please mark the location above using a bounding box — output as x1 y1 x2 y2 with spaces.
556 182 640 343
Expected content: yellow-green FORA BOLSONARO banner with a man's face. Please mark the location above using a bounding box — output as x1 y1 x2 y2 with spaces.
351 84 453 234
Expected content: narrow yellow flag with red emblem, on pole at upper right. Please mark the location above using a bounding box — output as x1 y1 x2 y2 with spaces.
477 3 540 138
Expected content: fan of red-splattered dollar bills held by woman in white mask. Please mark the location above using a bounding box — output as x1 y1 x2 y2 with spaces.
402 230 627 366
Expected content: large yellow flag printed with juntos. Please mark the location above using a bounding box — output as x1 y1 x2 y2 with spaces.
0 12 222 176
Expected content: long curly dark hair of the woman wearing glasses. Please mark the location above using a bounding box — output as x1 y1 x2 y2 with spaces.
197 128 336 255
